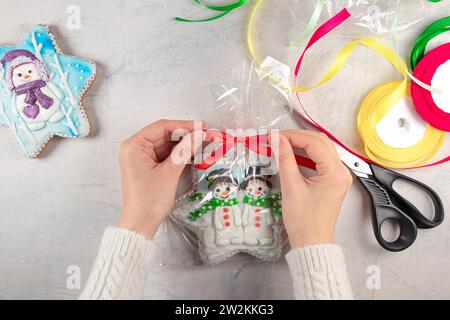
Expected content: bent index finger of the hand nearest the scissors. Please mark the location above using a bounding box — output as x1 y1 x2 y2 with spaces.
283 130 341 175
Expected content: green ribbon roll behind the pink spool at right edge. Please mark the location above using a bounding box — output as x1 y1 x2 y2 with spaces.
410 15 450 70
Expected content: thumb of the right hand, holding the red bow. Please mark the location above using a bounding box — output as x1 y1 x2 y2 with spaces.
271 133 304 190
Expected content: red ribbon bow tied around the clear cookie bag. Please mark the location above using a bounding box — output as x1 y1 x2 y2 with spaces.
195 130 316 170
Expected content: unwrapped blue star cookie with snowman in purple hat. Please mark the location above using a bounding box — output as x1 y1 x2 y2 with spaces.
0 25 96 157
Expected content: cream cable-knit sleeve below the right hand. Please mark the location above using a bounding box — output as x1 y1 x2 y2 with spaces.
286 244 353 300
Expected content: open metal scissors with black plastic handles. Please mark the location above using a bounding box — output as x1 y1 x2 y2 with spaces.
335 143 444 252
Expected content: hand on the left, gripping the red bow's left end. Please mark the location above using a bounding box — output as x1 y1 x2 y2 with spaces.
119 120 204 239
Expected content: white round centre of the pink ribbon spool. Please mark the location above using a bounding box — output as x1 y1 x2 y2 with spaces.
431 60 450 113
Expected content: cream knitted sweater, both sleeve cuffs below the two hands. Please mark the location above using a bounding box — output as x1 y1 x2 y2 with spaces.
80 227 353 299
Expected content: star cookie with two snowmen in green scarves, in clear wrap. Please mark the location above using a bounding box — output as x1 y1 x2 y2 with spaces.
172 133 285 264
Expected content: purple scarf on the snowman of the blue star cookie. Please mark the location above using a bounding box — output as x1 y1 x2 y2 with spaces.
14 80 53 119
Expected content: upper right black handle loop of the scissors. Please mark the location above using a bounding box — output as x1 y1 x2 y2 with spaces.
370 164 444 229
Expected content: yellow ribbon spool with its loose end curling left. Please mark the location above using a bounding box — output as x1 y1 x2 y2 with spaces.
293 38 445 168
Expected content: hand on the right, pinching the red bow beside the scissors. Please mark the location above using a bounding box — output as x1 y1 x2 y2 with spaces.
279 130 353 248
